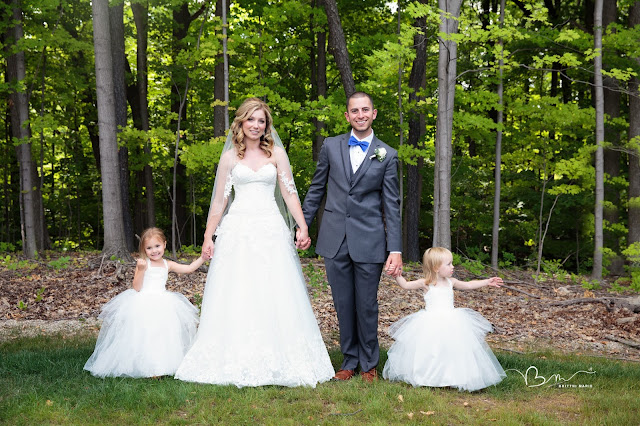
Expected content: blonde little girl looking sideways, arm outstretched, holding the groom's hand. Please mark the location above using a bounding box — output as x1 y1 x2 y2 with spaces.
382 247 506 392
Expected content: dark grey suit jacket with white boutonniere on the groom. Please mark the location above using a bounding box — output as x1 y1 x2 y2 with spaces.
302 133 402 263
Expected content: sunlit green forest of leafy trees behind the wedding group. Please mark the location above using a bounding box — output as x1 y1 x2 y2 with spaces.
0 0 640 290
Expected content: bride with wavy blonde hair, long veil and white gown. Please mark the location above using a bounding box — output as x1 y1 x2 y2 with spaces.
175 98 334 387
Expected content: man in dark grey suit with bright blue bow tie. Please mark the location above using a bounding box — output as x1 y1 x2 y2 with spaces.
300 92 402 382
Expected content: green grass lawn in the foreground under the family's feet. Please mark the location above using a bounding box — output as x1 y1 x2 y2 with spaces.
0 337 640 425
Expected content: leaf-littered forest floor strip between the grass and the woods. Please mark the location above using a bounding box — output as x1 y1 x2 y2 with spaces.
0 252 640 361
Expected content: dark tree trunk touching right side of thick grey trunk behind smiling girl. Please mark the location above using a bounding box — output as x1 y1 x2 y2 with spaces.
109 3 135 252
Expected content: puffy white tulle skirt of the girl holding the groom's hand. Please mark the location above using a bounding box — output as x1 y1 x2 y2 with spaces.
382 308 506 391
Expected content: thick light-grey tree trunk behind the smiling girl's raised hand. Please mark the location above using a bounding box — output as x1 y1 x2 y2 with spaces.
91 0 130 260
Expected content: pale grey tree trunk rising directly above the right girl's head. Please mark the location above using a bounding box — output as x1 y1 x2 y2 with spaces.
433 0 462 249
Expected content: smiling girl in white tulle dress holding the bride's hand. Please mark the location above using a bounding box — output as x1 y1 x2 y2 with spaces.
84 228 204 377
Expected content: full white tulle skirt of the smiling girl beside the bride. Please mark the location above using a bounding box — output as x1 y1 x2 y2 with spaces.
84 289 198 377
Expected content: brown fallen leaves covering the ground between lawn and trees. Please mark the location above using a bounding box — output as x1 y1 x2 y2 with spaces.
0 253 640 359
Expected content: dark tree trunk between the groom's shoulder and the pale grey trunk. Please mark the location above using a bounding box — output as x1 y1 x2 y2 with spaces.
398 0 427 262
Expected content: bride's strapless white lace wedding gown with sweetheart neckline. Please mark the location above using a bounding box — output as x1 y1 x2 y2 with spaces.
175 163 334 387
